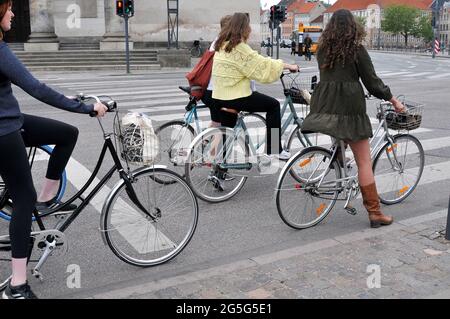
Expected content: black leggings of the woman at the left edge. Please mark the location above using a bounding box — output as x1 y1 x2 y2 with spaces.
0 115 78 258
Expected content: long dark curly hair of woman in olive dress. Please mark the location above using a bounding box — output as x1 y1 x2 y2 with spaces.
318 9 366 69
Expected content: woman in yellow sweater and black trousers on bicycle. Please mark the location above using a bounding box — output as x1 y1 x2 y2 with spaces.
212 13 298 159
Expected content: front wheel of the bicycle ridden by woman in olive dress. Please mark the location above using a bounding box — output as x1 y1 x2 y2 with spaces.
373 134 425 205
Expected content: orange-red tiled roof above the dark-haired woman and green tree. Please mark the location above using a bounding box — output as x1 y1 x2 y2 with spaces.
326 0 433 13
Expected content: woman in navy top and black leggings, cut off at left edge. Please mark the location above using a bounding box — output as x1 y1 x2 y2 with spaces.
0 0 107 299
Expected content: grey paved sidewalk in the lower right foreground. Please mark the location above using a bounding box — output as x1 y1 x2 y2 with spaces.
85 211 450 299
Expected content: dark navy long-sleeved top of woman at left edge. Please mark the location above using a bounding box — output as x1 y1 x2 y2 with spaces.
0 41 94 136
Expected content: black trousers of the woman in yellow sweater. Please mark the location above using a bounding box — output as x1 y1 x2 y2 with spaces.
216 92 283 154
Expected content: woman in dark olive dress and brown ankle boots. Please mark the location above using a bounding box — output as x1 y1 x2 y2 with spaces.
302 9 405 228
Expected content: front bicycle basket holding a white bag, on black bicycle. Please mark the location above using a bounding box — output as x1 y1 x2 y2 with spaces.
118 113 159 166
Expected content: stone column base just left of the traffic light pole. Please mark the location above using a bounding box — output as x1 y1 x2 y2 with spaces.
100 0 133 51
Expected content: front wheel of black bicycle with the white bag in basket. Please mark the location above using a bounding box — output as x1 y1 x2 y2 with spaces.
101 167 198 267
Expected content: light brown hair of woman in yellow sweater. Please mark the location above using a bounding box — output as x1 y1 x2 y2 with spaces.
214 12 252 53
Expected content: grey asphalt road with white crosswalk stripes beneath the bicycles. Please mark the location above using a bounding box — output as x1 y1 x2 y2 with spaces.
0 49 450 298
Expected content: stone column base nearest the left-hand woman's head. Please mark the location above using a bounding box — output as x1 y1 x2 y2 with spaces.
24 0 59 51
